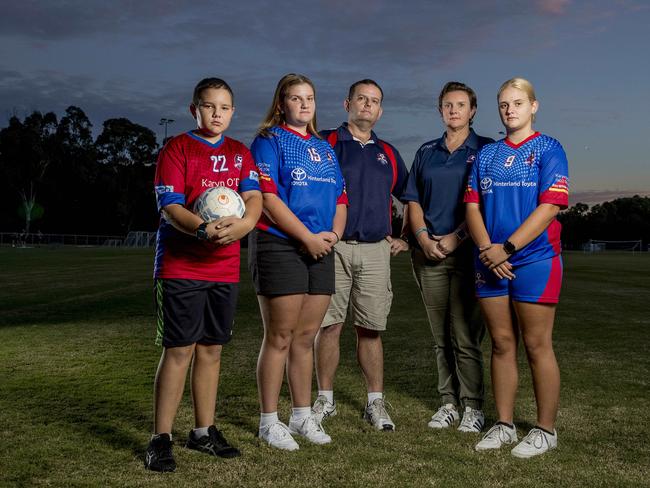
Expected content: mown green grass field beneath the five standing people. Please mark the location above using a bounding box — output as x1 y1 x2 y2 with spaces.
0 248 650 488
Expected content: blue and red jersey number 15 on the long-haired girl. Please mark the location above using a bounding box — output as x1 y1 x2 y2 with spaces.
251 126 348 239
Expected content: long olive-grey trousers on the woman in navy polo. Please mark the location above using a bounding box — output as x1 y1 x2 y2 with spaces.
411 246 485 409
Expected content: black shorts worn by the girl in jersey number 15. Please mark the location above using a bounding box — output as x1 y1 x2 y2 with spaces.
248 229 334 296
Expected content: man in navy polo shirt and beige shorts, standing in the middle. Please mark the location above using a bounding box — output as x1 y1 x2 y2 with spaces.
313 79 408 431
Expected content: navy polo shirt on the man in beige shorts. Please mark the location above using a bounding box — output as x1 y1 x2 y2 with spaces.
320 123 408 242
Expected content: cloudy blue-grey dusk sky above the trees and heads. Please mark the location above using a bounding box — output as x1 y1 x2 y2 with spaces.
0 0 650 203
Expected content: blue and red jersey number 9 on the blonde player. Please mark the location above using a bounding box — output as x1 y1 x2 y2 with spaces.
465 132 569 266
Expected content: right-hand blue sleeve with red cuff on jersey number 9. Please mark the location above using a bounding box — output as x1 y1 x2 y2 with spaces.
538 146 569 209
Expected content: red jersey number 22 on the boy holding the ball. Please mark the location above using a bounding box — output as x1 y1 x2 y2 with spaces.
154 132 260 283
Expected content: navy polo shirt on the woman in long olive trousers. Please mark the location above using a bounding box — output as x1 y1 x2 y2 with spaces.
402 130 494 235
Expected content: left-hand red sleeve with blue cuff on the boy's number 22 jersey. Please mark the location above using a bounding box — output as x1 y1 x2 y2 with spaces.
154 139 186 212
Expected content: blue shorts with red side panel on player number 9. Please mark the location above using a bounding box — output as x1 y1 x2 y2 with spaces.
474 254 563 303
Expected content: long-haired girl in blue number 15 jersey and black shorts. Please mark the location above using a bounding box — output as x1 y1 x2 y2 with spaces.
249 74 347 450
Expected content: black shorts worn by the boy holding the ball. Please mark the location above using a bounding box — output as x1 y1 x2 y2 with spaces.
154 278 239 347
